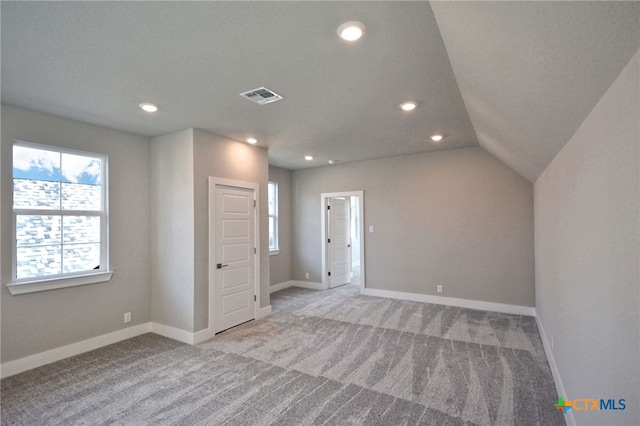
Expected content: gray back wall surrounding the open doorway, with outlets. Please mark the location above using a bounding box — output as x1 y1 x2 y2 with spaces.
292 148 534 306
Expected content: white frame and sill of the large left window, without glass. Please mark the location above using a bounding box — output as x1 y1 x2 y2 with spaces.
7 141 113 295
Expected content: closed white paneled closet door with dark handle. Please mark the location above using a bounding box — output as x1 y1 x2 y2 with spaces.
212 185 255 333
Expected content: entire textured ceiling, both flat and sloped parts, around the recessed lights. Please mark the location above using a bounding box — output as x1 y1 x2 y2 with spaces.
1 1 640 181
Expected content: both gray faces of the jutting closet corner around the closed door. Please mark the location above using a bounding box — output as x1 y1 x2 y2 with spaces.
152 129 269 332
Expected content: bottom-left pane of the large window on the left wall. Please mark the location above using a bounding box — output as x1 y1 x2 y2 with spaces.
16 245 62 279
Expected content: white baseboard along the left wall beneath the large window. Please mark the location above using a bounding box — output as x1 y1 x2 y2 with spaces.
0 322 151 379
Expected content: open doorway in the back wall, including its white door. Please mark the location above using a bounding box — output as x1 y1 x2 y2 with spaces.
321 191 365 292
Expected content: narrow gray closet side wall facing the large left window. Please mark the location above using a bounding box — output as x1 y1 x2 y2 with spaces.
151 130 195 332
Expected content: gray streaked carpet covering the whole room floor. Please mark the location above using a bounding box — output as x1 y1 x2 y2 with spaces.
1 286 564 425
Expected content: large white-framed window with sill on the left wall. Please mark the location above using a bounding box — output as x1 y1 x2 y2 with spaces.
9 142 111 294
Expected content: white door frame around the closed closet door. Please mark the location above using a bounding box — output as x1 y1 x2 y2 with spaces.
207 176 260 337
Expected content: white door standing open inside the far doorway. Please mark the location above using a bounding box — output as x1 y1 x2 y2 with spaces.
327 197 351 288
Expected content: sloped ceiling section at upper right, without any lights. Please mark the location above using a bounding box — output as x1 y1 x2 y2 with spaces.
432 1 640 182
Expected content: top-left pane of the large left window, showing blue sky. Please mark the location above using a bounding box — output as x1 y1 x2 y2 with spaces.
13 145 60 182
